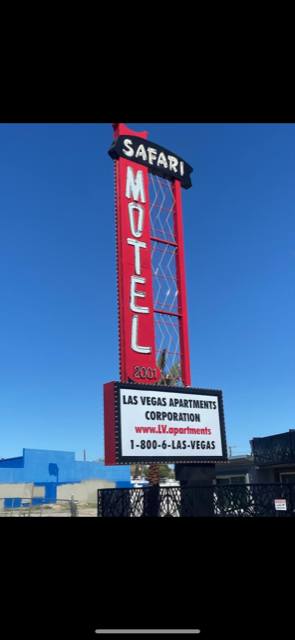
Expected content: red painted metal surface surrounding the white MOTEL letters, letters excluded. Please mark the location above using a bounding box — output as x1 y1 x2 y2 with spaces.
113 123 161 384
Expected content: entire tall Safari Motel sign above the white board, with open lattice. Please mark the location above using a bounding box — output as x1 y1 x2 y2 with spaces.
109 123 192 386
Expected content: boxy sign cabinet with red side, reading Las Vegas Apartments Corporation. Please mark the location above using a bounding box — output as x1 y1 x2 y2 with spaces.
104 382 227 466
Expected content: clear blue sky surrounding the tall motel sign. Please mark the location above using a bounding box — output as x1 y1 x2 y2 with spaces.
0 123 295 459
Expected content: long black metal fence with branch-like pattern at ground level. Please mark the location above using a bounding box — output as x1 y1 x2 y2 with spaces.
97 483 295 518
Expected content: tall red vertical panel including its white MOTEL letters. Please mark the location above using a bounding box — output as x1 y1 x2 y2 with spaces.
115 124 161 383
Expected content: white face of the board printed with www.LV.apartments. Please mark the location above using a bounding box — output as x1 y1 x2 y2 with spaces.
119 386 224 460
